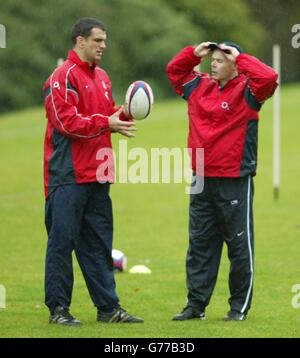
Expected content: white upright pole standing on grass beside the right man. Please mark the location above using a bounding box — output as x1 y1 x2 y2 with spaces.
273 45 281 200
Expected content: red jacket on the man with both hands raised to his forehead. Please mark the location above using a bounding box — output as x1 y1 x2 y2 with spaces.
167 47 277 177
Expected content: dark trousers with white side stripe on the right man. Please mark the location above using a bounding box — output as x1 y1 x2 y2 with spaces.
186 176 254 314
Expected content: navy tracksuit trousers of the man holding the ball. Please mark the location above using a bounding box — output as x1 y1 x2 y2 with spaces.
45 183 119 314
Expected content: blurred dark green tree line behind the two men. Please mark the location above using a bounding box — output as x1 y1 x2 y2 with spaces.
0 0 300 112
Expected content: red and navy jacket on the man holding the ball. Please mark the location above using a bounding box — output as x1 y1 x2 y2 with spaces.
44 50 125 197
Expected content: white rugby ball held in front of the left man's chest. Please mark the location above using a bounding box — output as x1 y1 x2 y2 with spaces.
125 81 154 119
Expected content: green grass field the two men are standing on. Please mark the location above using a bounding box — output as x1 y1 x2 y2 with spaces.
0 85 300 338
